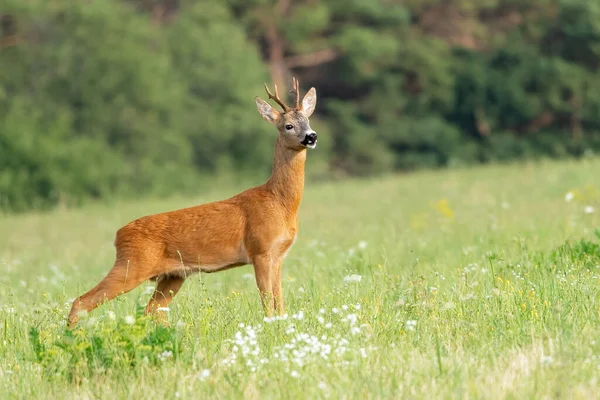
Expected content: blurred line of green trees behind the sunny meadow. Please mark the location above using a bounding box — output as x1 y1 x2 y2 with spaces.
0 0 600 210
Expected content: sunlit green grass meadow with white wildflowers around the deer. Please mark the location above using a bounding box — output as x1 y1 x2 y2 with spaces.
0 159 600 399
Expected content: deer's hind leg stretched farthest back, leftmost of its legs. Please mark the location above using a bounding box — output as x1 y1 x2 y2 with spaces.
68 262 150 327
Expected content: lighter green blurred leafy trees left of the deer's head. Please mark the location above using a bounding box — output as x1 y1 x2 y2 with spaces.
0 0 269 210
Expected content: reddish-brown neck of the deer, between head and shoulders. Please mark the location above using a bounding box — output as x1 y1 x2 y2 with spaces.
266 137 306 214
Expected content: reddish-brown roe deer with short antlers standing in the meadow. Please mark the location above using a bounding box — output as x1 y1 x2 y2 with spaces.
69 78 317 326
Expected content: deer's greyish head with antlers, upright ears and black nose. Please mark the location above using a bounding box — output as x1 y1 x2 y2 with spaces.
255 78 317 150
